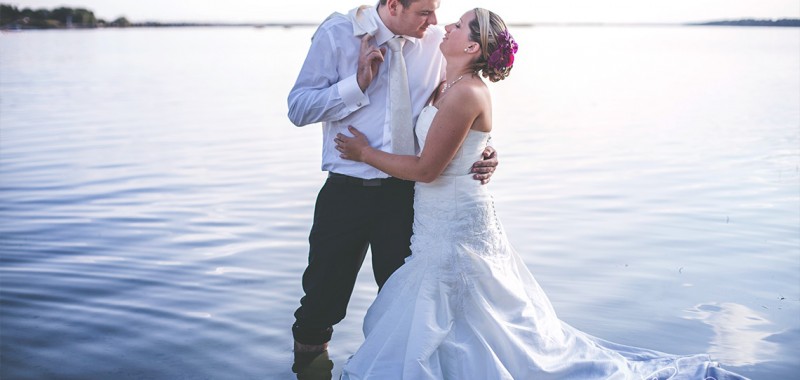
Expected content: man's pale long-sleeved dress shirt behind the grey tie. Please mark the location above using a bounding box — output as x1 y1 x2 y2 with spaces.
288 7 445 179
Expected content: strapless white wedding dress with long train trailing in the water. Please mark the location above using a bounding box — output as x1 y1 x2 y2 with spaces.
342 106 743 380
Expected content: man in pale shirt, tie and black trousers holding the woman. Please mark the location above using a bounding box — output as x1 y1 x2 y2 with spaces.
288 0 497 355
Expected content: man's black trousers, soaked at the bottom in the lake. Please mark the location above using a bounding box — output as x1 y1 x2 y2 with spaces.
292 173 414 344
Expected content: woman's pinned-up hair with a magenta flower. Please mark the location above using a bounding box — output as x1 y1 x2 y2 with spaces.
469 8 517 82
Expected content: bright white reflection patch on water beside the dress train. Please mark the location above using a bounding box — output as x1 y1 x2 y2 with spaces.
687 303 780 366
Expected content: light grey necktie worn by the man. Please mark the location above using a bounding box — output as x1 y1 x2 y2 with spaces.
386 36 415 155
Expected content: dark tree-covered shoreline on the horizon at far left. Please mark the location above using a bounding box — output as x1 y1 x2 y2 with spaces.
0 4 131 29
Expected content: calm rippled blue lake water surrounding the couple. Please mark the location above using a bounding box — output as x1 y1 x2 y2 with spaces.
0 27 800 379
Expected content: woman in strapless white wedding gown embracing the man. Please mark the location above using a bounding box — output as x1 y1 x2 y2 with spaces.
335 8 743 380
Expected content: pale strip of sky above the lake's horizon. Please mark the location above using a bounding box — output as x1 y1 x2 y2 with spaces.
9 0 800 24
